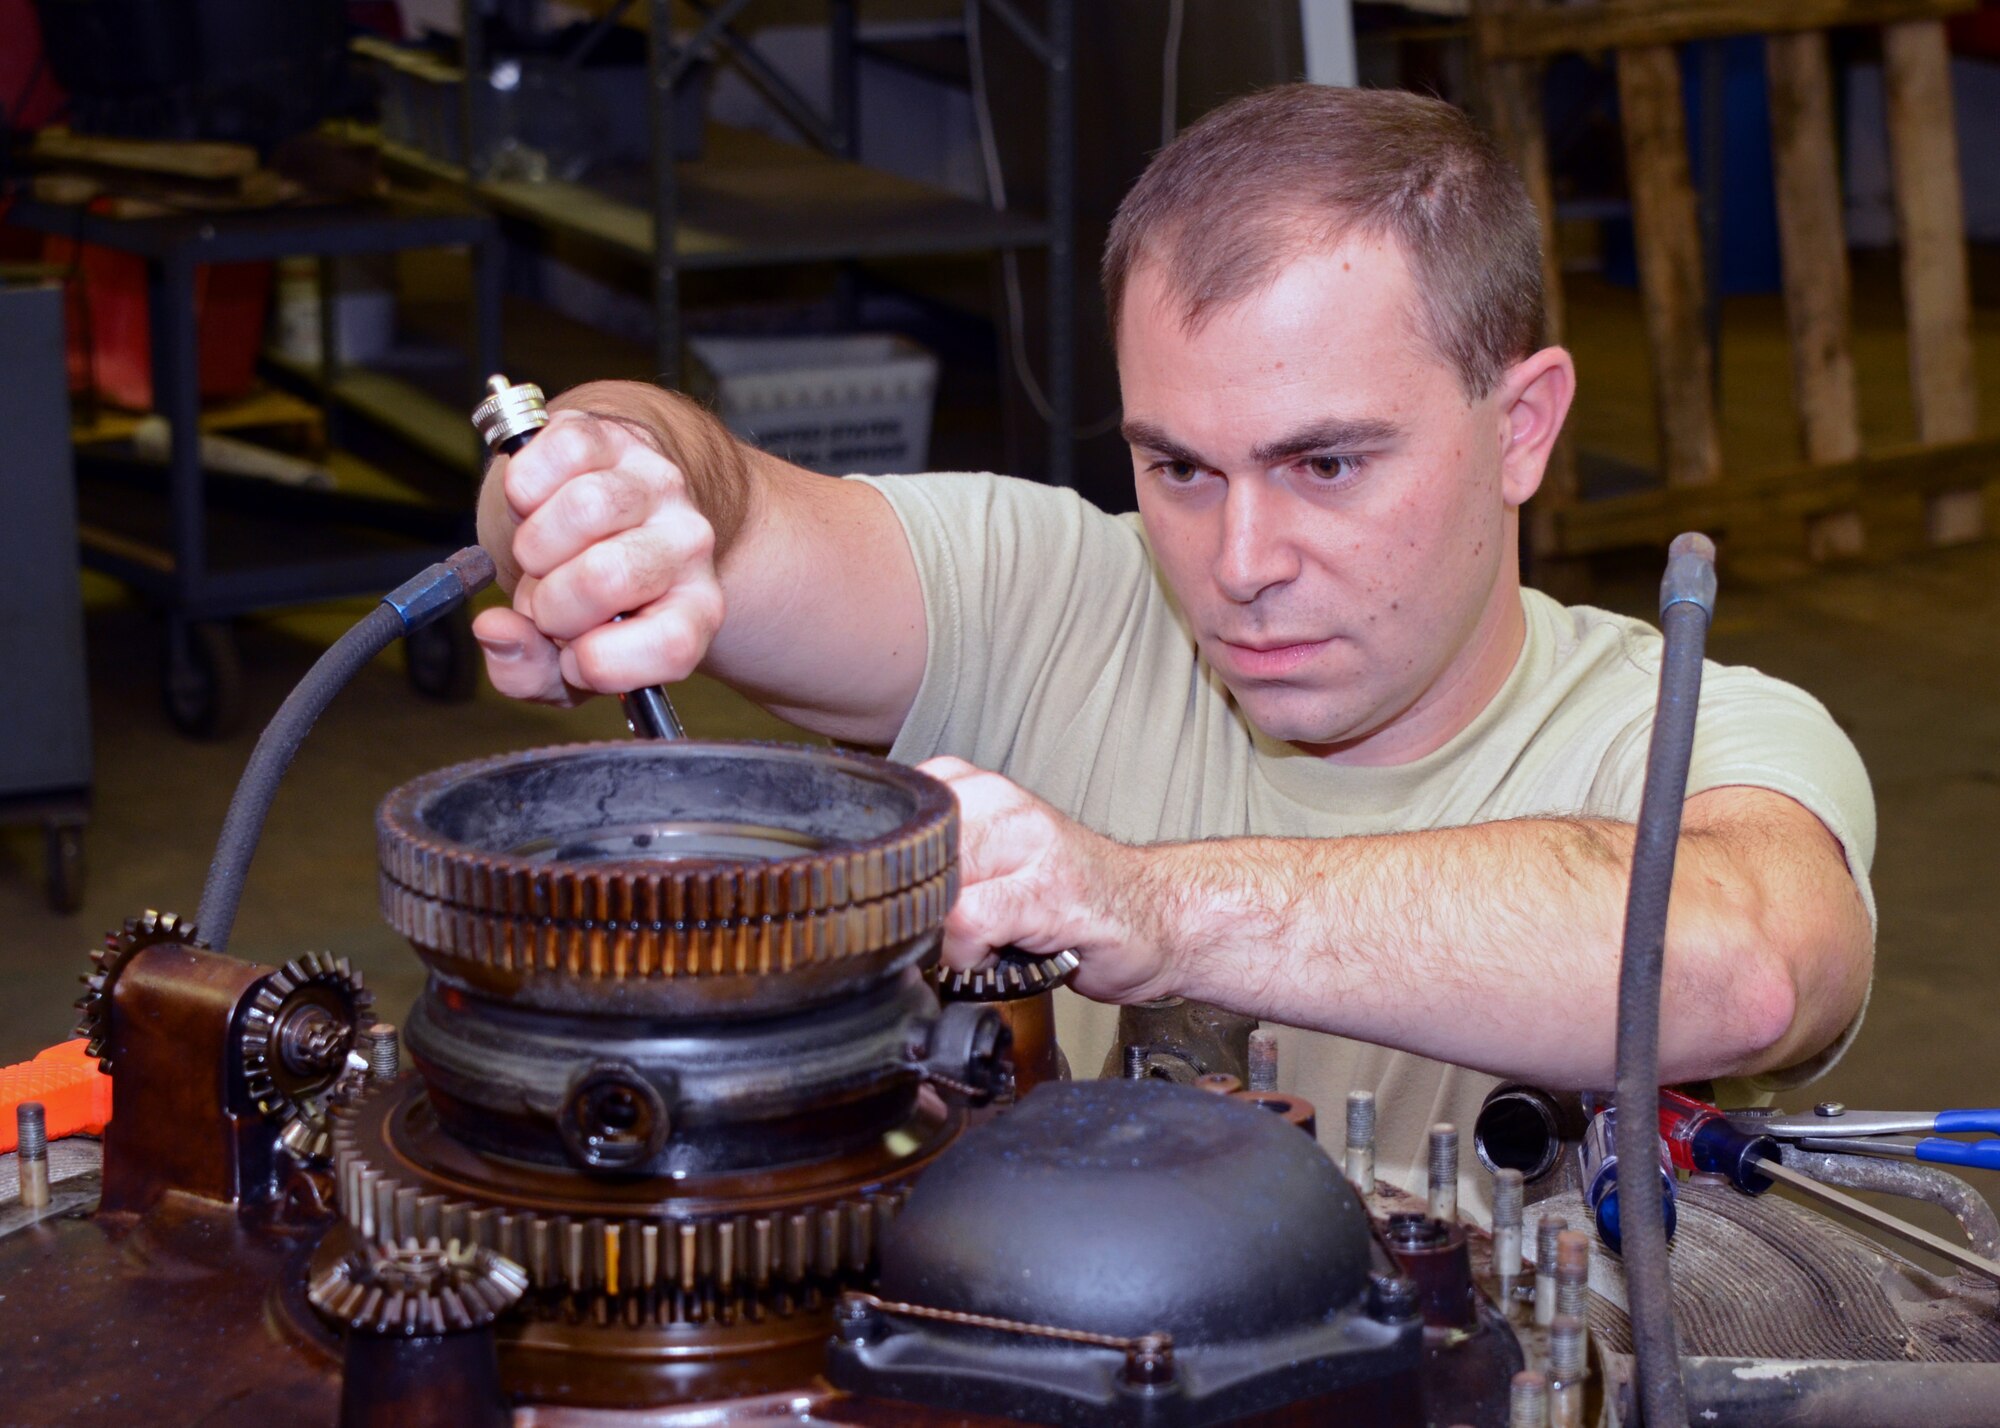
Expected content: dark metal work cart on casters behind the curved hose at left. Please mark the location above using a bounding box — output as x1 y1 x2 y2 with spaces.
8 200 500 738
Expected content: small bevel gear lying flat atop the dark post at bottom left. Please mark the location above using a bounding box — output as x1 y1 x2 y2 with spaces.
306 1238 528 1338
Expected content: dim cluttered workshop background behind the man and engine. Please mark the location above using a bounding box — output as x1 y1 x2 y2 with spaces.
0 0 2000 1248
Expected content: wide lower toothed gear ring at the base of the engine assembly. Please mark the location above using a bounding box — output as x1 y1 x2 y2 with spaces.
334 1078 962 1324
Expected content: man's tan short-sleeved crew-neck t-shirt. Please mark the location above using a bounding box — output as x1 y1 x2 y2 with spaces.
860 476 1876 1208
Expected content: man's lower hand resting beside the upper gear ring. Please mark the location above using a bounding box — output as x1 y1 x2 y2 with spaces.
918 758 1172 1002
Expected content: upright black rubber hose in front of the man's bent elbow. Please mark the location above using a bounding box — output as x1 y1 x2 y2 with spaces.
1616 534 1716 1428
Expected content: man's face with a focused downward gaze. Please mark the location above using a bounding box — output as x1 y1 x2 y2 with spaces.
1118 240 1514 752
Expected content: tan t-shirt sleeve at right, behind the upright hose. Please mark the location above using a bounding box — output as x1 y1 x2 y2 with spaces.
1598 662 1876 1104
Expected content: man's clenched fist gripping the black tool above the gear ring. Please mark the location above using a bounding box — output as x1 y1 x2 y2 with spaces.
472 410 722 704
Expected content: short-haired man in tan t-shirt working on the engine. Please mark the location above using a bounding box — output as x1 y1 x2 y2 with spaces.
476 86 1874 1184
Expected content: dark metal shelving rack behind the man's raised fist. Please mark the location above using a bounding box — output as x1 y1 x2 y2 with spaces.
444 0 1076 486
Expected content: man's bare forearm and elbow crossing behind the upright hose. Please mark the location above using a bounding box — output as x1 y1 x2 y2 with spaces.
1130 796 1870 1088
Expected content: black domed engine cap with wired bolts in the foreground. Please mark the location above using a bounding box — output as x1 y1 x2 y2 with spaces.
830 1080 1422 1428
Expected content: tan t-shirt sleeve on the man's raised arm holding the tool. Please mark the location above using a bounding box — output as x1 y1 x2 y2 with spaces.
848 474 1156 772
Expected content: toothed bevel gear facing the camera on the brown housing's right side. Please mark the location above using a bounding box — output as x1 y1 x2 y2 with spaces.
236 952 374 1160
